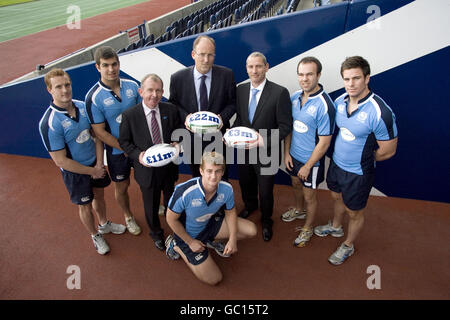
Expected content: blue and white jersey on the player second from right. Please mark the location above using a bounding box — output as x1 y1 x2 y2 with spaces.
290 84 336 167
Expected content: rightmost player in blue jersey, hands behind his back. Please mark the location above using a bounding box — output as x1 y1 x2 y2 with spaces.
314 56 398 265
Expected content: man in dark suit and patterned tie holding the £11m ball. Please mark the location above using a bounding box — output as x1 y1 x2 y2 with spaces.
119 74 181 251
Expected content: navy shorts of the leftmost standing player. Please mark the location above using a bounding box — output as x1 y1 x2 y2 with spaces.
61 163 111 205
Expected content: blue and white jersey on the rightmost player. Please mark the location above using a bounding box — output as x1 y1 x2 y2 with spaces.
333 92 397 175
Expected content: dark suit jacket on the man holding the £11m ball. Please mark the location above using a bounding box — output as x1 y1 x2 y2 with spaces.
119 102 181 188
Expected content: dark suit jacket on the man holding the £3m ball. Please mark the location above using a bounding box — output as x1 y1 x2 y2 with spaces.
233 80 292 165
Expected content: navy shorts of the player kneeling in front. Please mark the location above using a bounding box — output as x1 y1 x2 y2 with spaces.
174 211 225 266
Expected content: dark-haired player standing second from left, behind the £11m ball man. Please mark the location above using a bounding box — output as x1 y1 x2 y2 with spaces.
86 46 141 235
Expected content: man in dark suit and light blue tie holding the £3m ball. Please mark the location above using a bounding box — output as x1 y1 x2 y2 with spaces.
234 52 292 241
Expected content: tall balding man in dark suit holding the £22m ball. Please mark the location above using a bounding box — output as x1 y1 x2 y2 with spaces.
169 35 236 180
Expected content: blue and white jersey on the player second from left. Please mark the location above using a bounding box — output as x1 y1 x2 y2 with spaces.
85 79 141 154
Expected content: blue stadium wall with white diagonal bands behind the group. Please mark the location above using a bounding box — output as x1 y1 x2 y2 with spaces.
0 0 450 202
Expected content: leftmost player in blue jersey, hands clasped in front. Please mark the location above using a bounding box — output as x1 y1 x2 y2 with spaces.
39 69 126 254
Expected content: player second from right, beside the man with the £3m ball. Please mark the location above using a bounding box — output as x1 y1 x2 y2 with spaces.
281 57 336 247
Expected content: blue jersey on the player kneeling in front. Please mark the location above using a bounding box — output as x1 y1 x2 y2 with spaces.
169 177 234 238
